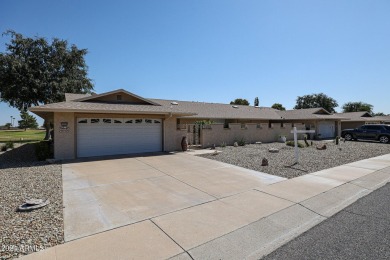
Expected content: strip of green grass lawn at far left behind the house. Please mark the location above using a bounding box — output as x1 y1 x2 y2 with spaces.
0 130 45 143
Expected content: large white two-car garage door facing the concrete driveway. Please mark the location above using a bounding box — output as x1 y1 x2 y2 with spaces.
77 118 162 157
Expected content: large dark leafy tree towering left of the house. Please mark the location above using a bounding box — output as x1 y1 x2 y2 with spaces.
0 31 93 140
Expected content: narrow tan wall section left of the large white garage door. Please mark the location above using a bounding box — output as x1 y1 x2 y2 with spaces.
54 113 76 160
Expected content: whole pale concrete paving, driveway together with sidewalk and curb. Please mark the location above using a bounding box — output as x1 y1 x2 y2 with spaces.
23 153 390 260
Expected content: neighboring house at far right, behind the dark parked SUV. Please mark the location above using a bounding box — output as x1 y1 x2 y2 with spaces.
336 111 390 130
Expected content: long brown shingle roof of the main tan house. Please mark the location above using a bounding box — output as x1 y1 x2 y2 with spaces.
30 90 341 120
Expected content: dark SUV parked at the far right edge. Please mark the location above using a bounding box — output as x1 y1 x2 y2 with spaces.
341 124 390 143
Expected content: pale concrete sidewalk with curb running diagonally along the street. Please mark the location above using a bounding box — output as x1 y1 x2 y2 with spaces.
24 155 390 259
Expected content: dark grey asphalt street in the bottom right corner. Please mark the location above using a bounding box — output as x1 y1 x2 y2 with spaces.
262 183 390 260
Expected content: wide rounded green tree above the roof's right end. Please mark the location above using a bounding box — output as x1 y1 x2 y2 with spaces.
294 93 338 113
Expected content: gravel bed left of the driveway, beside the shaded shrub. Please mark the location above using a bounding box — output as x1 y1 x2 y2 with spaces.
0 144 64 259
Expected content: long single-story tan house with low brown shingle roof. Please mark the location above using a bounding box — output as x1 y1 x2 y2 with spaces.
30 89 343 159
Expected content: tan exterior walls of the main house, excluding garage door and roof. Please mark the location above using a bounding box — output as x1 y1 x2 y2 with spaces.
54 110 338 159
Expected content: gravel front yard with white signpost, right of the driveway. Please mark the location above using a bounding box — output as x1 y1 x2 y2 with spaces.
199 141 390 178
